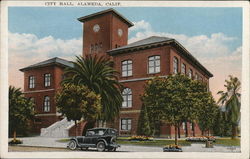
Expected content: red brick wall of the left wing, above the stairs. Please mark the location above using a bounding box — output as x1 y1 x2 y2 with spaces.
24 66 63 133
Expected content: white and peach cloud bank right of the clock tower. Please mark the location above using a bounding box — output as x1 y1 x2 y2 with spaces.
129 20 242 98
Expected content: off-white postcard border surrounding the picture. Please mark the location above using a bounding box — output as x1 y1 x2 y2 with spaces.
0 1 250 159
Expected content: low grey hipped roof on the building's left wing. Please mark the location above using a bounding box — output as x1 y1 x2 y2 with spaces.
20 57 74 71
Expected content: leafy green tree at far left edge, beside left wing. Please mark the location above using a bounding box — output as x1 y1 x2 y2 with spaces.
9 86 34 142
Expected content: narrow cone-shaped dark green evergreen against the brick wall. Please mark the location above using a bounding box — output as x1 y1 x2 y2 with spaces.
137 105 152 136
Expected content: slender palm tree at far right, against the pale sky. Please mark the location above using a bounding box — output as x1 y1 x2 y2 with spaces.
217 75 241 139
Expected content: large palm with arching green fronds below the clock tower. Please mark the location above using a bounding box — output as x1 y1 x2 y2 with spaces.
62 55 123 121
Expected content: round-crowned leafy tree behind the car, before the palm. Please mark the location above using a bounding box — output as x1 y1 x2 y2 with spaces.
56 84 101 137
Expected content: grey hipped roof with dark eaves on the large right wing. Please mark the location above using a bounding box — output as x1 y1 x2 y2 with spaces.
107 36 213 77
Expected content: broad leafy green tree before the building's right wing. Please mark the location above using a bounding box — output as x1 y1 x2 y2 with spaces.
142 74 215 145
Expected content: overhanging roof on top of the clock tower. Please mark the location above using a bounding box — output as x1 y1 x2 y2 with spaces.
78 8 134 27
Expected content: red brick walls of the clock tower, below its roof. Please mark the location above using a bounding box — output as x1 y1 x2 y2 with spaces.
83 13 128 56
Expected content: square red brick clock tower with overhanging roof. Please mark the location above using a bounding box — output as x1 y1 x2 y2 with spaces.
78 9 133 56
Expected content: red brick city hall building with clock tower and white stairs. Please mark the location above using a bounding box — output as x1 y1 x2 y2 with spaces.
20 9 213 137
